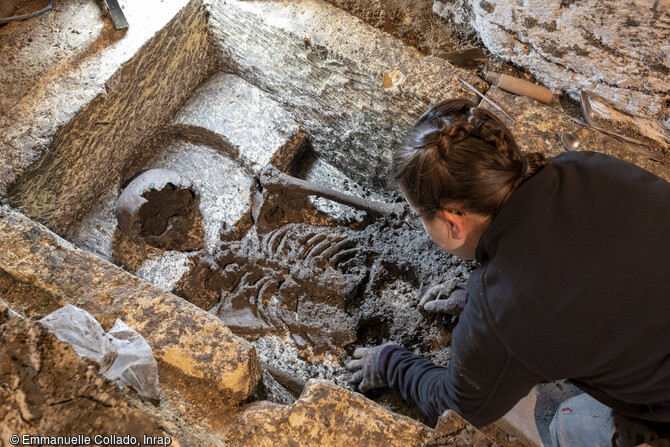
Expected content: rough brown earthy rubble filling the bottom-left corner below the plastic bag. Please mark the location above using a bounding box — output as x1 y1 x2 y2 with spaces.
0 306 183 446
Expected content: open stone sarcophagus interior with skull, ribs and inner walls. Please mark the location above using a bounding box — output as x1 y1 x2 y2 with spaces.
3 1 474 430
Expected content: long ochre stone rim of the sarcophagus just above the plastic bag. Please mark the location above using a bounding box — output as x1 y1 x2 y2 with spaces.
0 206 261 405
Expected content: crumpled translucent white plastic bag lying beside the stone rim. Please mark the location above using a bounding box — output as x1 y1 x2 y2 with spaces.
40 304 159 399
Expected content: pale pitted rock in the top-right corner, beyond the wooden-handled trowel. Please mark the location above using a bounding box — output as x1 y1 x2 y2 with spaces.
435 0 670 143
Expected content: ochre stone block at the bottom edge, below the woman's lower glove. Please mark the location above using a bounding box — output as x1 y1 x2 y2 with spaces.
229 380 432 447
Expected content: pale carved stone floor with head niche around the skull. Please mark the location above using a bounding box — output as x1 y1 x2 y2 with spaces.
69 73 308 298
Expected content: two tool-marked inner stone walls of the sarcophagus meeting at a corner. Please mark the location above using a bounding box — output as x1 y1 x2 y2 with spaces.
9 1 488 235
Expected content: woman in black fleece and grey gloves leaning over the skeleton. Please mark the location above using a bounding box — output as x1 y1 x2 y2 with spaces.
348 100 670 446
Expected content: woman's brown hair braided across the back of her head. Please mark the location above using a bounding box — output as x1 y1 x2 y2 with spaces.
392 99 548 216
